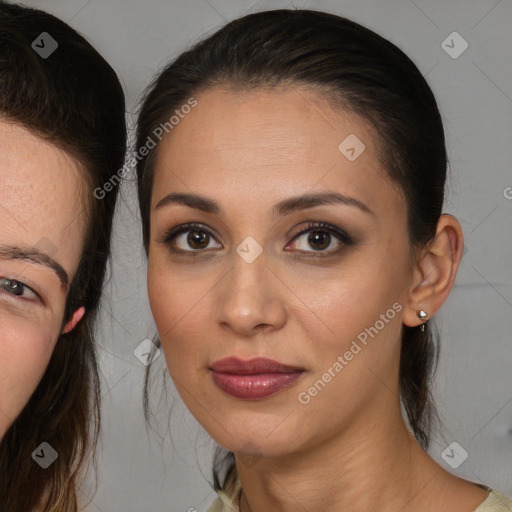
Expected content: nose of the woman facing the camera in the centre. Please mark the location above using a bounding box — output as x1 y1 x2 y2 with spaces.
215 247 287 337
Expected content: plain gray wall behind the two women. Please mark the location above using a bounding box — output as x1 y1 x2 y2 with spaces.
18 0 512 512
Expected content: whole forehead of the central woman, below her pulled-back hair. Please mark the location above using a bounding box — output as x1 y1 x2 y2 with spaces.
153 86 400 216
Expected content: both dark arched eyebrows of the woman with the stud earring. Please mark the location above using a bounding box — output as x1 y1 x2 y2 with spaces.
155 192 375 217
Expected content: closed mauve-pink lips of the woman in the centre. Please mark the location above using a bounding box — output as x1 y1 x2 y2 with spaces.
209 357 305 400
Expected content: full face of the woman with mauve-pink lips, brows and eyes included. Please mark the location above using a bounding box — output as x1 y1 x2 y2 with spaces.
148 88 413 456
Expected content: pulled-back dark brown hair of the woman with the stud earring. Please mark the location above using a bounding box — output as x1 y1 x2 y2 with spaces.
137 9 447 489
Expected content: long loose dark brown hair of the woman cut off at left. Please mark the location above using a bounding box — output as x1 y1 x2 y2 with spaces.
0 1 126 512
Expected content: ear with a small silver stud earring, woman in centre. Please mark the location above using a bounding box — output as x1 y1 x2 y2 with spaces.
402 214 464 327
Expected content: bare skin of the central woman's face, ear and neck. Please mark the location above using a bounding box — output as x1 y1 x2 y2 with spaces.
148 87 487 512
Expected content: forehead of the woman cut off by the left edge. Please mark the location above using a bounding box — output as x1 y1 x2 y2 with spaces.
0 121 86 274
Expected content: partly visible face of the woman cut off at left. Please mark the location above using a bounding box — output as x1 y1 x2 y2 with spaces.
0 121 84 439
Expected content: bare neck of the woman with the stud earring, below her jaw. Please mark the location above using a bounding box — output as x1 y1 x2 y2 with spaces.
237 402 447 512
